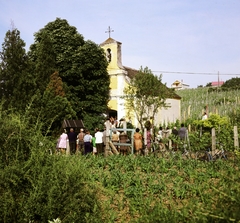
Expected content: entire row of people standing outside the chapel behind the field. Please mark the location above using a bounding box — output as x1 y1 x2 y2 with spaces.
56 124 187 155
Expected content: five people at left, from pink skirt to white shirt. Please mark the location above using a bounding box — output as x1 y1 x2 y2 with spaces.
56 128 105 155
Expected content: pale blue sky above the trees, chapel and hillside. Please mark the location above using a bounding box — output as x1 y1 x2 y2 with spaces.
0 0 240 88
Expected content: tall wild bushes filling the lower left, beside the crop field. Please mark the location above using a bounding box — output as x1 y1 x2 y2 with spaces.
0 108 102 223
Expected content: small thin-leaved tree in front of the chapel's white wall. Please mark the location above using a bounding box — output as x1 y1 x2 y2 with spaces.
123 67 169 130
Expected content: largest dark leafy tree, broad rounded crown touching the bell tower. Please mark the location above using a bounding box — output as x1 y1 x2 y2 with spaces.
29 18 110 128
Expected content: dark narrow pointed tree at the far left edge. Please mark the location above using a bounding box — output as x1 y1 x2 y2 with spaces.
0 28 35 110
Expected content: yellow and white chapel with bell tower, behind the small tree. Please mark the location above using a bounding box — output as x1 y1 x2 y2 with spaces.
100 36 181 126
